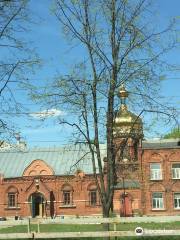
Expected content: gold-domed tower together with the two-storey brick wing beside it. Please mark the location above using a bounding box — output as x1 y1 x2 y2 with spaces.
114 87 180 216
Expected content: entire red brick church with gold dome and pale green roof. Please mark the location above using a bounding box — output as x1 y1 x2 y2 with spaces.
0 87 180 218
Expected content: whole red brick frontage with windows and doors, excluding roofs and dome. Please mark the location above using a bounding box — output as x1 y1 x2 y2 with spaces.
0 140 180 217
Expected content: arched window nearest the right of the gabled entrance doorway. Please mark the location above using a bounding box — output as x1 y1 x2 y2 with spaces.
61 184 73 206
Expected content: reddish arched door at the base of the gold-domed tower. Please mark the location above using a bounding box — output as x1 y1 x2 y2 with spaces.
120 193 132 217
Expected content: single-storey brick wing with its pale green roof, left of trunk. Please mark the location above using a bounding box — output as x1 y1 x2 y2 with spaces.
0 144 107 217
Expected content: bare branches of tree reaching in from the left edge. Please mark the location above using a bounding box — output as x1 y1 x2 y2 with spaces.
0 0 37 138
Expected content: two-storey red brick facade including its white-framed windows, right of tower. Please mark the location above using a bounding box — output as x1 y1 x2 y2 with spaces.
142 147 180 215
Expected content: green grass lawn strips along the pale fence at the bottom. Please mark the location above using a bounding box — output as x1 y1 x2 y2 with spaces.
0 222 180 240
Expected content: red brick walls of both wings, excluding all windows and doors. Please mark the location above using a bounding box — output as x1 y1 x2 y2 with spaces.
0 146 180 217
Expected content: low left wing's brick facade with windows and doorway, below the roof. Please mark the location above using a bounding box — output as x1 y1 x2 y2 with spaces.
0 169 101 217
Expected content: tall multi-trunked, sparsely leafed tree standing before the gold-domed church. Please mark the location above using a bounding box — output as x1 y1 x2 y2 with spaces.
33 0 179 217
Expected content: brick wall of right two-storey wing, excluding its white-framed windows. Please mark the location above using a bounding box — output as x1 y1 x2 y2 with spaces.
142 149 180 215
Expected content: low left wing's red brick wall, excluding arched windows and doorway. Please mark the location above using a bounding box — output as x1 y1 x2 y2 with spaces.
0 175 101 217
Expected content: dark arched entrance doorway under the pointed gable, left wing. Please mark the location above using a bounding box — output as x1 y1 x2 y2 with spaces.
29 193 46 218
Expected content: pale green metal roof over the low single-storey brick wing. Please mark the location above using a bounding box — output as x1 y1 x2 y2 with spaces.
0 144 106 178
